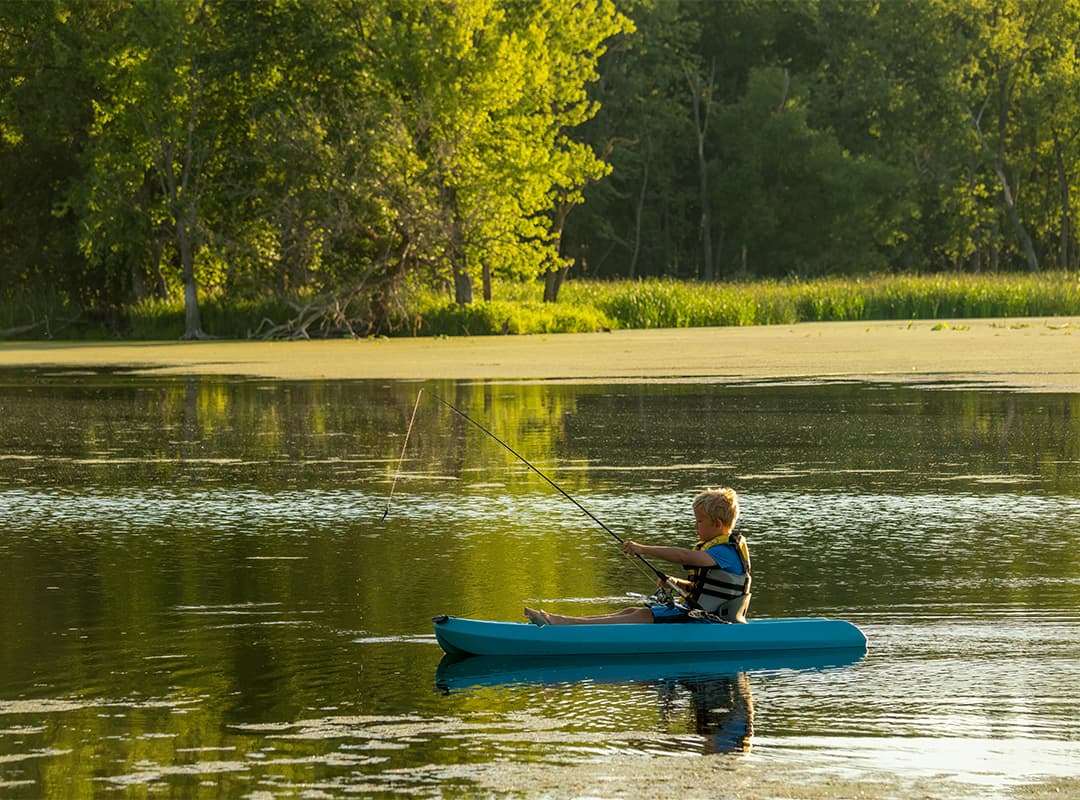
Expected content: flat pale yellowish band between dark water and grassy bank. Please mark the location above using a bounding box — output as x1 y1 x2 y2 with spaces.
0 316 1080 392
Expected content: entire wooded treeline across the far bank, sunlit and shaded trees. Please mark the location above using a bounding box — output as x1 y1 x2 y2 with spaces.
0 0 1080 337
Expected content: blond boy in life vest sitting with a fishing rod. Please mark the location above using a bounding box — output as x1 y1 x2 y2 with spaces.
525 488 751 625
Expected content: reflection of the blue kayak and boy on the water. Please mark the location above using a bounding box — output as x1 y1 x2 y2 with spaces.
435 648 866 752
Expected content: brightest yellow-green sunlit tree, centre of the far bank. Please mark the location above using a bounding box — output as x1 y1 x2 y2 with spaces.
349 0 625 304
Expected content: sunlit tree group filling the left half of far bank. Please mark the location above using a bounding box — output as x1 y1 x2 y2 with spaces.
0 0 629 337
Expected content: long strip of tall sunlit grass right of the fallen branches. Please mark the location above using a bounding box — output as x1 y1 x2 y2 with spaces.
403 272 1080 336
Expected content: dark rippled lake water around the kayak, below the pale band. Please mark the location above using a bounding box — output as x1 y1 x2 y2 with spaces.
0 371 1080 798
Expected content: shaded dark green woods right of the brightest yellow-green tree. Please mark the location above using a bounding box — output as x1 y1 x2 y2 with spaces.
568 0 1080 279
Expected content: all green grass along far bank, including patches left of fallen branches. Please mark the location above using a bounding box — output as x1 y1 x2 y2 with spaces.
8 272 1080 340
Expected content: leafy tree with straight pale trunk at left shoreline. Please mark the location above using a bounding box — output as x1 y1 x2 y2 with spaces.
82 0 236 339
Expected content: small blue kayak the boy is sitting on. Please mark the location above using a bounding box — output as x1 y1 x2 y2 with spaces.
433 615 866 655
